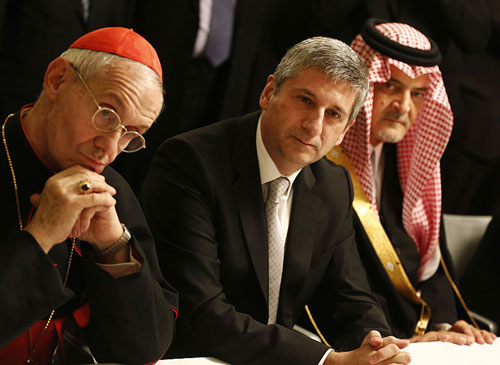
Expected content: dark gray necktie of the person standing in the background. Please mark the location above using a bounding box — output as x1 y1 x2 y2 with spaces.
205 0 234 67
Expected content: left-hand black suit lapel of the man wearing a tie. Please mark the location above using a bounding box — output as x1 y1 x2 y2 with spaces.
233 113 269 302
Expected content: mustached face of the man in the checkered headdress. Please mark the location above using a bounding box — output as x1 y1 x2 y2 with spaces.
370 65 429 146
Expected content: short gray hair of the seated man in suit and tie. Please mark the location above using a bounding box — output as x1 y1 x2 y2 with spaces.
274 37 369 121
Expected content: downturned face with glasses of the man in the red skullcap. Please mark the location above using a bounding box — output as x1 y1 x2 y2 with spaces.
44 62 163 173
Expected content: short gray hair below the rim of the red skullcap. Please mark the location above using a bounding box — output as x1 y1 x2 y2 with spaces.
61 48 163 94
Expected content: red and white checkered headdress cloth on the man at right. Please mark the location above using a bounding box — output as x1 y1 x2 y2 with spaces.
342 23 453 279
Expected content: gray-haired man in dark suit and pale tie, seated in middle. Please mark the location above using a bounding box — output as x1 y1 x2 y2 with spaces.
141 37 409 364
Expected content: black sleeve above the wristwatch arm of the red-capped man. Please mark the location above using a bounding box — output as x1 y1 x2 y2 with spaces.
83 168 177 364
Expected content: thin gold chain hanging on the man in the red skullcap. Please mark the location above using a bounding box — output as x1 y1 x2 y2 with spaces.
2 114 76 364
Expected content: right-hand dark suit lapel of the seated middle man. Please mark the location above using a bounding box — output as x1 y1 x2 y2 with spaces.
278 166 322 325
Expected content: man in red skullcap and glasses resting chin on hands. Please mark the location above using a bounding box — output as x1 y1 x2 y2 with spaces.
0 28 177 364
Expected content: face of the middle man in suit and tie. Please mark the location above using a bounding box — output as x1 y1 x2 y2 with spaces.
260 68 357 175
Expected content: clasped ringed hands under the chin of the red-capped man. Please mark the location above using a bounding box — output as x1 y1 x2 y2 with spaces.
25 165 123 253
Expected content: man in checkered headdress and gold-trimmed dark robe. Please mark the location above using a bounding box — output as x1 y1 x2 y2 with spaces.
329 19 494 344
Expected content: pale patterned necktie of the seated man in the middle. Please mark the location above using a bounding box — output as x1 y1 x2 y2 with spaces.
266 177 290 323
